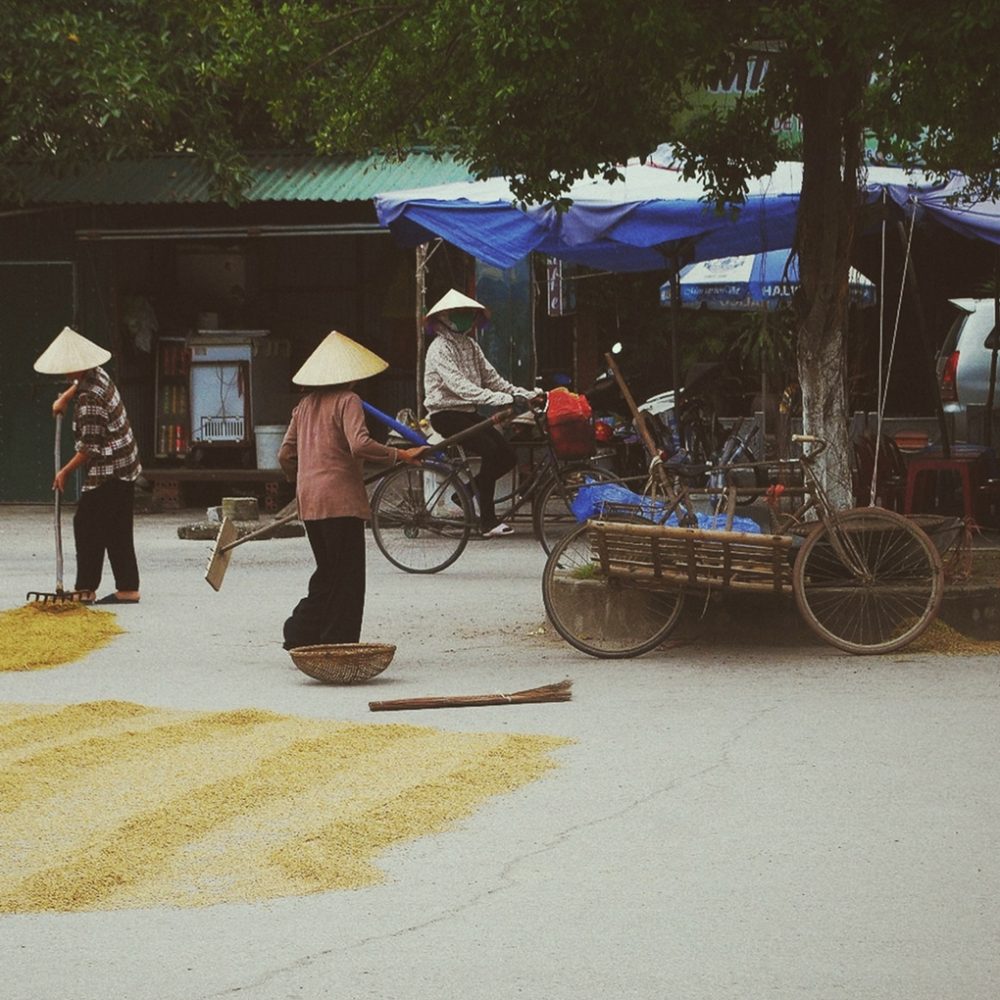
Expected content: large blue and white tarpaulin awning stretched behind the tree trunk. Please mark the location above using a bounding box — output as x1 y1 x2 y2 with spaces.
375 153 952 271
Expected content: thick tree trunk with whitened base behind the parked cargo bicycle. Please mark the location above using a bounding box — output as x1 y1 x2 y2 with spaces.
795 54 866 508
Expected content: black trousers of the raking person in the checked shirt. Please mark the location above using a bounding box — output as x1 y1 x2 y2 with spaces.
73 479 139 590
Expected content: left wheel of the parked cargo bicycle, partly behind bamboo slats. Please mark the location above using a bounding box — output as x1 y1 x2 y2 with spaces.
542 524 684 659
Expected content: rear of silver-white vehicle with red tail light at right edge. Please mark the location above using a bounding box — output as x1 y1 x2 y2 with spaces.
937 299 1000 413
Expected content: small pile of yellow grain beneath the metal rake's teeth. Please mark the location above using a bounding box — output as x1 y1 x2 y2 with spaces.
0 601 125 671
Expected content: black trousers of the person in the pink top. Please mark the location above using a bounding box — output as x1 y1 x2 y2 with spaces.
284 517 365 649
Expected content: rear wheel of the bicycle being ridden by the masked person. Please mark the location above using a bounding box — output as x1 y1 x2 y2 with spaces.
371 463 475 573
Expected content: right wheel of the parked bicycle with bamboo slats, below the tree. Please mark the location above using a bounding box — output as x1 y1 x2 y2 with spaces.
792 507 944 653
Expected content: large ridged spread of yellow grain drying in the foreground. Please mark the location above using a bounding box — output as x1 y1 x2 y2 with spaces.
0 702 570 913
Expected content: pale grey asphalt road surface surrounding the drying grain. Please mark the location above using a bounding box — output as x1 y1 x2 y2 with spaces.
0 507 1000 1000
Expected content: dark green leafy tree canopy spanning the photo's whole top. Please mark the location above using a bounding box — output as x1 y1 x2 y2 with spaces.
0 0 1000 205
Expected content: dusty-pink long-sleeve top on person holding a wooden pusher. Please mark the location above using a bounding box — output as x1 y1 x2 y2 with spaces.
278 386 399 521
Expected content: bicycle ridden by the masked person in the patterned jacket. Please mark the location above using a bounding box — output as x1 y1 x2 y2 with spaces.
371 396 617 573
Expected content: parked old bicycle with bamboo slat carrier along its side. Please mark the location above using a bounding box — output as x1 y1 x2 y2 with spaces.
542 435 944 658
